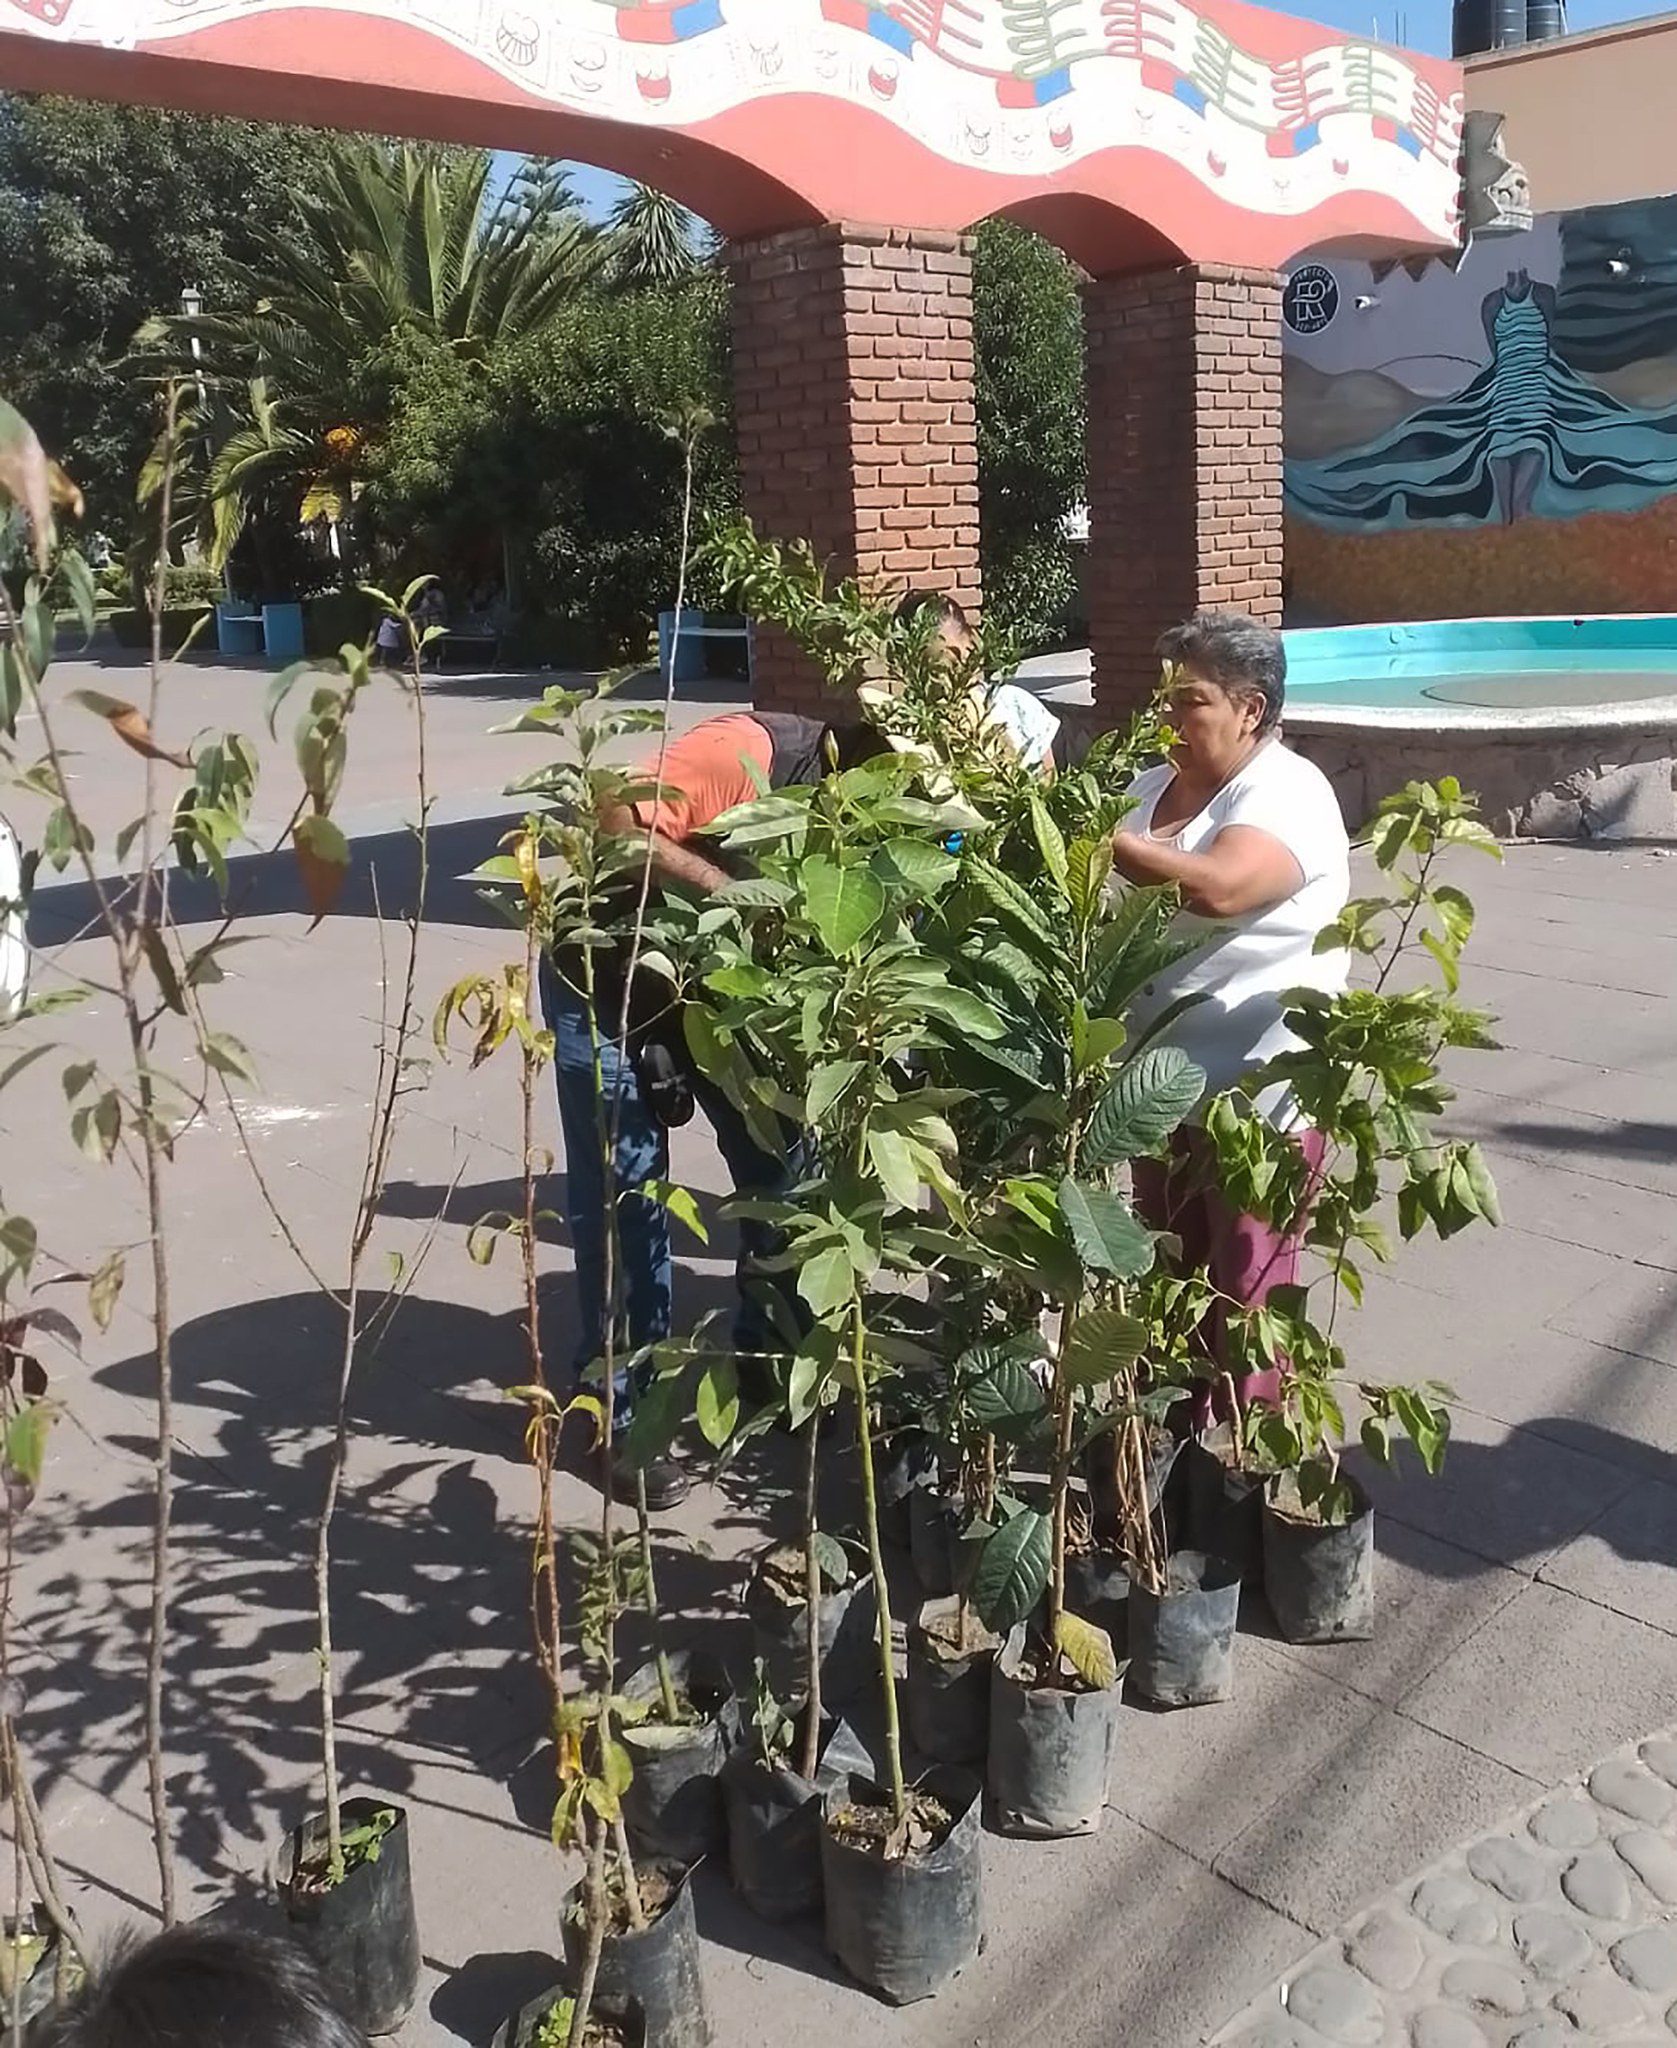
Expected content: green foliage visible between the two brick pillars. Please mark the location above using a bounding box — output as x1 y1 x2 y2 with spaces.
973 221 1089 647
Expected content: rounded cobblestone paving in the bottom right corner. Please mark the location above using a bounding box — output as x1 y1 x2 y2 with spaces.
1212 1729 1677 2048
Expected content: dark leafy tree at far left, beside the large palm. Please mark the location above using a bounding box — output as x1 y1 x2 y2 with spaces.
0 94 326 532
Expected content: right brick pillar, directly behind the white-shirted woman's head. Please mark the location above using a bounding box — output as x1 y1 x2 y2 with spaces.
1085 264 1282 725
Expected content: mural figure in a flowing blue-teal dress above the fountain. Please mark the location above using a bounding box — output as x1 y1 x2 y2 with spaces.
1286 270 1677 532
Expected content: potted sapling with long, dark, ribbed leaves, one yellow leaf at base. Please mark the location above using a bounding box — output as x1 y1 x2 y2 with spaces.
950 815 1204 1810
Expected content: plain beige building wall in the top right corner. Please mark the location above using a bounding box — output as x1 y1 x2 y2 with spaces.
1466 14 1677 213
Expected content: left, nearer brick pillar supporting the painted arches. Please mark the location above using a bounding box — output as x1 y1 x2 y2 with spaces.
729 225 981 711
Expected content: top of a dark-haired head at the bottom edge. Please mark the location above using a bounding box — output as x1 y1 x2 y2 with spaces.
31 1927 367 2048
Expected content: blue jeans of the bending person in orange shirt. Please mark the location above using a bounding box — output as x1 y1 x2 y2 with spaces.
541 961 805 1407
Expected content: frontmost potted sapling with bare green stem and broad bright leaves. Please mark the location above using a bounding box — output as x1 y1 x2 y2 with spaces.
686 754 1001 2003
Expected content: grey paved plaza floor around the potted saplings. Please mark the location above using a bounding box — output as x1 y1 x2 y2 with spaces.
13 666 1677 2048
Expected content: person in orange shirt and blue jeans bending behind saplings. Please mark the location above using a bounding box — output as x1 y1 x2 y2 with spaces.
543 711 885 1509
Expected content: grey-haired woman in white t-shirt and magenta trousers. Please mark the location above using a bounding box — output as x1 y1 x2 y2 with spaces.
1112 612 1351 1401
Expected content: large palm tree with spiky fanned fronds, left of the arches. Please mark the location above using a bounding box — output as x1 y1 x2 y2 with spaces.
152 139 604 561
